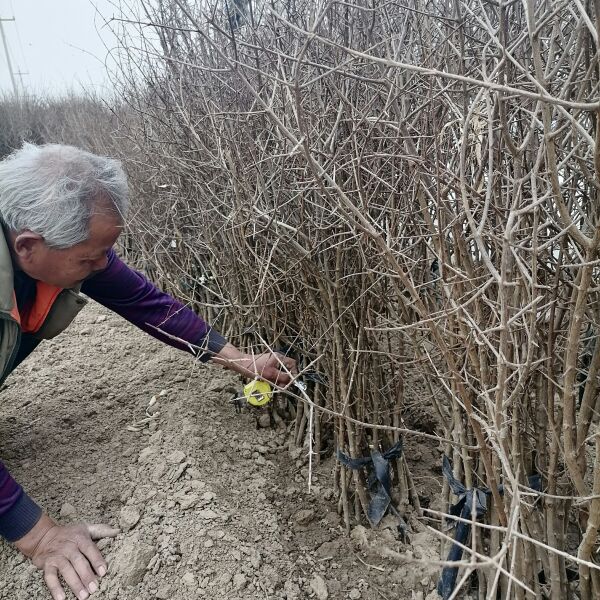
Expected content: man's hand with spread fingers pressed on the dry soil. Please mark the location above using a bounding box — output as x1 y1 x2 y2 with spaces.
15 515 119 600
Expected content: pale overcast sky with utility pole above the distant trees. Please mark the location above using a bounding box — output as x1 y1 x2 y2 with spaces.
0 0 129 95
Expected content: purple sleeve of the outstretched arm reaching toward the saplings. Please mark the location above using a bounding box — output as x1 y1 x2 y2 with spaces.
81 250 226 361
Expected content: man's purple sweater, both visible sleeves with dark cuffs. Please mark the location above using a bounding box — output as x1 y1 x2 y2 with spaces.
0 250 226 542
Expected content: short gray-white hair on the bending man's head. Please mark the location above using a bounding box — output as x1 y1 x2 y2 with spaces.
0 143 129 248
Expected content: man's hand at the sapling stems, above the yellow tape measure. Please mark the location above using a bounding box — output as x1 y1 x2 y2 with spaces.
212 344 298 387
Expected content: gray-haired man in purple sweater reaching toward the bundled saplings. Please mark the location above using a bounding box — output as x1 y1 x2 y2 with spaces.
0 144 296 600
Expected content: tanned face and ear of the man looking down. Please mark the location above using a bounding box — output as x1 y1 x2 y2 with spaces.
12 213 123 288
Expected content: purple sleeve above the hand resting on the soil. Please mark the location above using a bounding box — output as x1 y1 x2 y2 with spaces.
0 462 42 542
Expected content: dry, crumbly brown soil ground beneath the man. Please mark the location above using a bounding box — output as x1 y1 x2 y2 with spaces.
0 304 439 600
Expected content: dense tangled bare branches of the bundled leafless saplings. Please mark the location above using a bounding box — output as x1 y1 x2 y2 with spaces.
98 0 600 599
